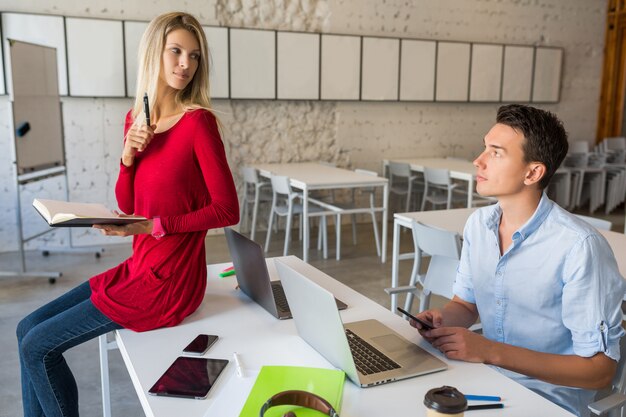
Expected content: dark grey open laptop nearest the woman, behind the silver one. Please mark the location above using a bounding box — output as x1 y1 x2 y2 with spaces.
224 227 347 320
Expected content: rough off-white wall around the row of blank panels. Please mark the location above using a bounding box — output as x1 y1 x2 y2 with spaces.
0 0 606 251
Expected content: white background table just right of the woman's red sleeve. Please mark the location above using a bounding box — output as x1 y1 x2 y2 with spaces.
252 162 389 263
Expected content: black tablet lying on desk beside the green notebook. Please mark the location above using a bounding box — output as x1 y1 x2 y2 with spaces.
148 356 228 399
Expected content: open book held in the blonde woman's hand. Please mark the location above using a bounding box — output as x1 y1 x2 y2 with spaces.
33 198 147 227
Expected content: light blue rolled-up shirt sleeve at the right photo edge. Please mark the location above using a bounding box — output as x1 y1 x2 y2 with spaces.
562 235 626 361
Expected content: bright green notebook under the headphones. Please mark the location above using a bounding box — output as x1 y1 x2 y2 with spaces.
239 366 346 417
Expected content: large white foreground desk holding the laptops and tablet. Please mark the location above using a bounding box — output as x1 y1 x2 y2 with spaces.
116 259 572 417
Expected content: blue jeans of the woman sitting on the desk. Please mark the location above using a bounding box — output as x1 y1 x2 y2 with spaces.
17 282 122 417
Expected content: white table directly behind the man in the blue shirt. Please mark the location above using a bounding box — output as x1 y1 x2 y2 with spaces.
391 208 626 312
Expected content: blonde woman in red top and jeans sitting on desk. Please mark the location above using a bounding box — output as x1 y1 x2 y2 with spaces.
17 13 239 417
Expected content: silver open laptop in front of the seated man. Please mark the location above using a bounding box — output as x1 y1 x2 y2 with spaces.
275 257 447 387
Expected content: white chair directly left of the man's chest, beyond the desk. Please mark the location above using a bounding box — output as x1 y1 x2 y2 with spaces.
385 221 461 312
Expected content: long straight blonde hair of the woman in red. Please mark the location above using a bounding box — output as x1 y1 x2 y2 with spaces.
132 12 211 124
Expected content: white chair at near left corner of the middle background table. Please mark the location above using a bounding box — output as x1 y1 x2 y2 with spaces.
265 175 328 259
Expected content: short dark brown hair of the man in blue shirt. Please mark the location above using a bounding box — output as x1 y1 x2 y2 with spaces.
496 104 568 190
